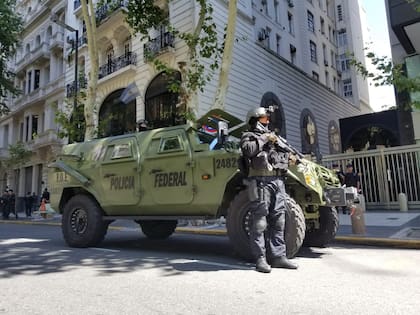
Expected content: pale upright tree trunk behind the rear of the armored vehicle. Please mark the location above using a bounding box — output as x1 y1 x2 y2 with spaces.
76 0 99 141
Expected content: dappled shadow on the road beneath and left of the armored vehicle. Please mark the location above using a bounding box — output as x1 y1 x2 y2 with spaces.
0 232 251 278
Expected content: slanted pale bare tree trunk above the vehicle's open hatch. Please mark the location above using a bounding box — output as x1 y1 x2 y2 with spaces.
212 0 237 109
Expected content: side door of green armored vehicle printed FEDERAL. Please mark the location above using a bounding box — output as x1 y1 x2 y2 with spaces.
140 129 194 205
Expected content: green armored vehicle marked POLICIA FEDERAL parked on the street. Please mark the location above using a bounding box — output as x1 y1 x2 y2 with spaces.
48 110 354 258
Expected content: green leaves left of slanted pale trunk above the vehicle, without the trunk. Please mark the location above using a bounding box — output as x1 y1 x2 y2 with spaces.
126 0 223 118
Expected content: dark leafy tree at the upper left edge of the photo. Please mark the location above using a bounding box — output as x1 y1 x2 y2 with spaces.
0 0 23 115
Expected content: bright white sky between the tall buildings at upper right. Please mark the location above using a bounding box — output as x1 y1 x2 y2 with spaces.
359 0 395 111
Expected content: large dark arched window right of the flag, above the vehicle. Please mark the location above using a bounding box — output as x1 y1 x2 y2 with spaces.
145 72 185 128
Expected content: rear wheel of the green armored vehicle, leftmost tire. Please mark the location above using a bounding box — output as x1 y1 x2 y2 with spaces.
61 195 108 247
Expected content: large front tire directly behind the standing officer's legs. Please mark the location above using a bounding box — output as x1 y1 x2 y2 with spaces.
226 190 305 260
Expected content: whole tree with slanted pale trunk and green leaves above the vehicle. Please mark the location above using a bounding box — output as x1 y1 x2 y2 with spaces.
126 0 237 119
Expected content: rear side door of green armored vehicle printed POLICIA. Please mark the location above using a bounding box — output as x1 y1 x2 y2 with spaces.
99 137 140 206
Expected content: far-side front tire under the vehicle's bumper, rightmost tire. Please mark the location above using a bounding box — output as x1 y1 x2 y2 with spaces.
303 207 339 247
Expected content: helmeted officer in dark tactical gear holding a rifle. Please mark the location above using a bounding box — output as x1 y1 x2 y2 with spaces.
241 107 298 273
